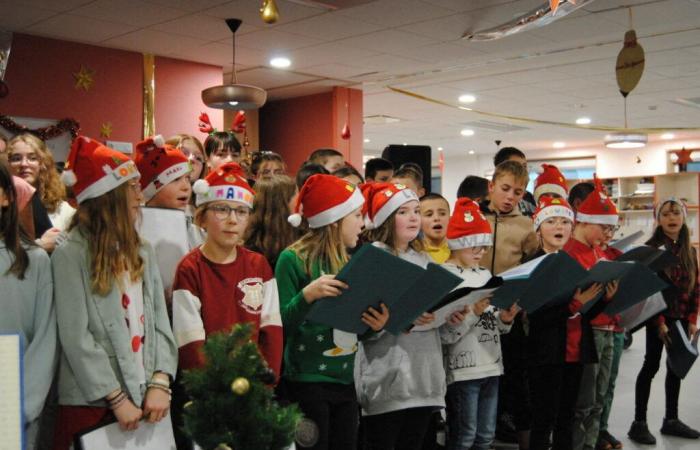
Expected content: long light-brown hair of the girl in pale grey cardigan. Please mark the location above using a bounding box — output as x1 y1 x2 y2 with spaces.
70 183 144 296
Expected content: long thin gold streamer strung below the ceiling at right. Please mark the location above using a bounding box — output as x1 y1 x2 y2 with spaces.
387 86 700 134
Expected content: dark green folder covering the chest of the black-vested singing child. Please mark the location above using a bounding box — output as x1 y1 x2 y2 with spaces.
491 252 588 313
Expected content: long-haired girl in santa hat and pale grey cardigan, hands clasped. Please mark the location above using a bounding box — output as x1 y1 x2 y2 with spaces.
51 136 177 450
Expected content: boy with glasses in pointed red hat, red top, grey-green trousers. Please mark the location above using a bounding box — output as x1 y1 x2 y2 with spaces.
564 177 618 449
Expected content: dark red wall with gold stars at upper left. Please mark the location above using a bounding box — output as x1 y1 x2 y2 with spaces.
0 34 223 151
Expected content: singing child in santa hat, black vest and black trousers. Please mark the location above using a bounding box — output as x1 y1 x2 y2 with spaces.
527 195 602 450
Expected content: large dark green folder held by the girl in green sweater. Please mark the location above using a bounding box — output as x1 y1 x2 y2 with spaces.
306 244 462 334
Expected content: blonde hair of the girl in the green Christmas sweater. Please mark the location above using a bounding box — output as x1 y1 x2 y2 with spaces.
289 223 350 276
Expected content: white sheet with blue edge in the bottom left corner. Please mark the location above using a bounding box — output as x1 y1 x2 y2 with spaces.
0 334 24 450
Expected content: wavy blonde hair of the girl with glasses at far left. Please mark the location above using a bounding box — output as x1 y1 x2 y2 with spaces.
7 133 66 213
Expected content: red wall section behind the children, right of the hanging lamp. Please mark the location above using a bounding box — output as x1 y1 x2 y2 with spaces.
260 87 363 173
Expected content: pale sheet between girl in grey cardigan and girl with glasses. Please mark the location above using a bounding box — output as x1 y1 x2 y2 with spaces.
139 208 190 292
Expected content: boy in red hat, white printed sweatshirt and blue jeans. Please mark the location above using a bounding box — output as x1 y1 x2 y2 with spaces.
440 198 517 450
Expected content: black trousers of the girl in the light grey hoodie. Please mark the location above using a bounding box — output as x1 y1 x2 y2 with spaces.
362 407 435 450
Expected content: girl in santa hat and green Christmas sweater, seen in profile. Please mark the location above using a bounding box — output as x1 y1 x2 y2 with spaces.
275 174 389 450
